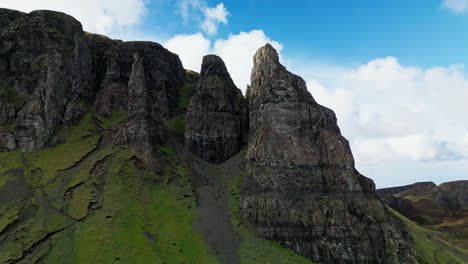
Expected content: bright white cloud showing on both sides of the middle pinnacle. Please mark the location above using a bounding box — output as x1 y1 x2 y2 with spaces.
165 30 283 89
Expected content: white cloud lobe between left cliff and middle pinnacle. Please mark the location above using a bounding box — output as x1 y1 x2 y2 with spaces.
164 33 211 71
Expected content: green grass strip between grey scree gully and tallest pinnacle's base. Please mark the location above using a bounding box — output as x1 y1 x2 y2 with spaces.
229 174 314 264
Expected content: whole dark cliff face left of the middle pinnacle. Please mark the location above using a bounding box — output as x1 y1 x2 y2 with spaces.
0 9 185 157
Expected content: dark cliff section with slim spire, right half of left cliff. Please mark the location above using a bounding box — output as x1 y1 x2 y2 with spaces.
95 42 185 157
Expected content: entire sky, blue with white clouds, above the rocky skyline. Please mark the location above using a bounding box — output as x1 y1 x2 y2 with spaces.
0 0 468 188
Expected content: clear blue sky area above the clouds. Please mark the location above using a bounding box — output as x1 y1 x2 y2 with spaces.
142 0 468 67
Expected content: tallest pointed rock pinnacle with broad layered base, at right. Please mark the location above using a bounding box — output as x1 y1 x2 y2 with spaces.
241 44 416 263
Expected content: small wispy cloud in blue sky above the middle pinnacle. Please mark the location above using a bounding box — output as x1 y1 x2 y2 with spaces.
178 0 229 35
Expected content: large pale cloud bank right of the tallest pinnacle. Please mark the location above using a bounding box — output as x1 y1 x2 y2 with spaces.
304 57 468 167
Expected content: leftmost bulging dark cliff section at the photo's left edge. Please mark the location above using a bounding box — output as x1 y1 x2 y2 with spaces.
0 9 91 151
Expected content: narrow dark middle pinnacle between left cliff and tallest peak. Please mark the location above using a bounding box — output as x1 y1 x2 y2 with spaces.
185 55 248 163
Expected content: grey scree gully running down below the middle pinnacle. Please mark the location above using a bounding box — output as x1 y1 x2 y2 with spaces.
168 136 242 264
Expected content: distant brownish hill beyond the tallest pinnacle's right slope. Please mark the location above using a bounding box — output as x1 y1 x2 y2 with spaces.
377 181 468 252
